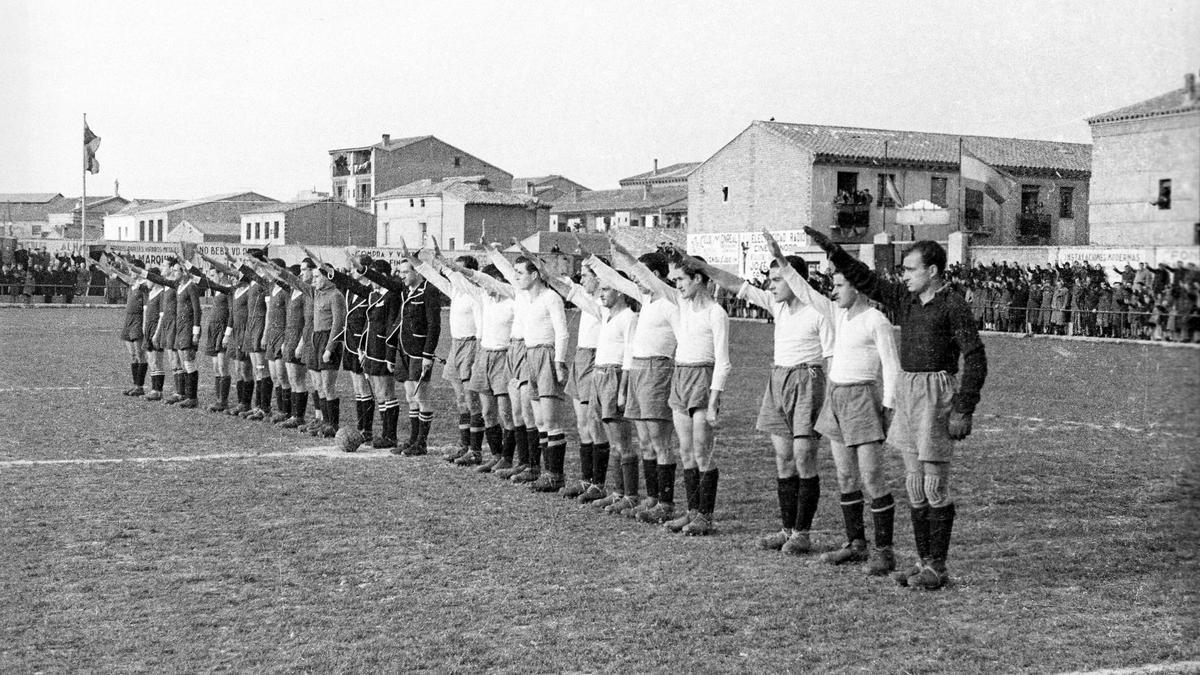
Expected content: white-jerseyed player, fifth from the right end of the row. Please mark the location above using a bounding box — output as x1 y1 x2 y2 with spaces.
593 240 679 518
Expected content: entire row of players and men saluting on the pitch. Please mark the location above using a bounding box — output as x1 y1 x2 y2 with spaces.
98 229 986 590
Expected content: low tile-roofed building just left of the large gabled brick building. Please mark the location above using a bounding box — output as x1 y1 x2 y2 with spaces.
550 185 688 232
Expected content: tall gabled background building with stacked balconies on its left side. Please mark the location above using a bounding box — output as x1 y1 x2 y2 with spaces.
329 133 512 209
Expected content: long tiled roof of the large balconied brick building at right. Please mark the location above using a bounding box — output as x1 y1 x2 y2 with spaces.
754 121 1092 173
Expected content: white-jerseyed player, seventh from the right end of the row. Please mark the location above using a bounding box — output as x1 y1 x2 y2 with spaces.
517 243 610 501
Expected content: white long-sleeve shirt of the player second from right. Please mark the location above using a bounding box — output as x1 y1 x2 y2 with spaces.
780 268 900 408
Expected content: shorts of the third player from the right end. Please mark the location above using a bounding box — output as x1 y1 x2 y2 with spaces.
755 364 824 438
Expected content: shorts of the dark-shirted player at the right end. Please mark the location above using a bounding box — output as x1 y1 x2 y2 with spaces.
888 371 959 461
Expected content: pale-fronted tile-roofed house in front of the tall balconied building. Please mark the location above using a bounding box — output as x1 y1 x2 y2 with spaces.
374 175 550 251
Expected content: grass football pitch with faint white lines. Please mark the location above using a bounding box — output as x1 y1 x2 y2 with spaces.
0 310 1200 673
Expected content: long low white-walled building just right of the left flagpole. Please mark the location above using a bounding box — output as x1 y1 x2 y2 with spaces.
104 192 278 241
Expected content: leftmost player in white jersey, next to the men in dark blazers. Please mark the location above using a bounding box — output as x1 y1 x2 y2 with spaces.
416 239 484 466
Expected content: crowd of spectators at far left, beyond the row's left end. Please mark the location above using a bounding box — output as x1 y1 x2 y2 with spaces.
0 247 108 303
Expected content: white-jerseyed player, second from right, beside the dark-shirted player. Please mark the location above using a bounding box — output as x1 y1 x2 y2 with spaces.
763 232 900 569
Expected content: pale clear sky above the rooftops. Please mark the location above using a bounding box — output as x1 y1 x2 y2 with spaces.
0 0 1200 199
